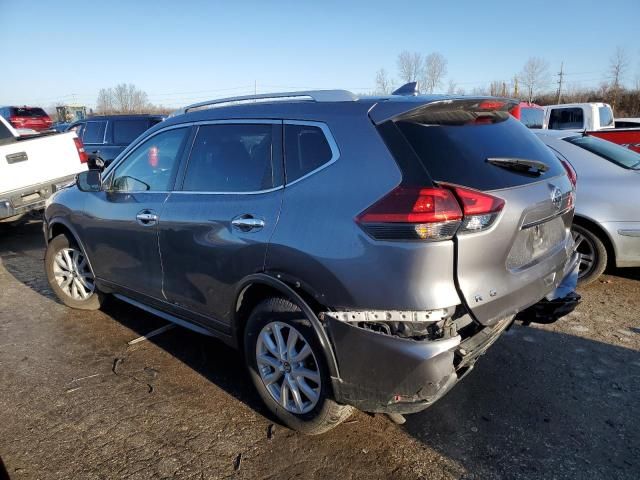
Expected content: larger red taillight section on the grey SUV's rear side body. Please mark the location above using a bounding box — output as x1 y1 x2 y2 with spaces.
356 186 462 240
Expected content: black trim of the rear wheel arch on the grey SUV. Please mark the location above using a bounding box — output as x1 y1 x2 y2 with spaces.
231 273 339 378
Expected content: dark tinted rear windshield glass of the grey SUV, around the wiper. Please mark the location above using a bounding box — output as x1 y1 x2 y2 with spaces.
397 116 565 190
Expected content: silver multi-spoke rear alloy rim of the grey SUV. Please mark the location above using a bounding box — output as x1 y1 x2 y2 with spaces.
256 322 321 414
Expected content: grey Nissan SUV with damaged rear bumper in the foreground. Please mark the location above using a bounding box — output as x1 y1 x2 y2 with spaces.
44 91 579 433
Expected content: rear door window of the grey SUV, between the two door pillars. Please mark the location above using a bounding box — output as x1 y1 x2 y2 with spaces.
182 124 282 193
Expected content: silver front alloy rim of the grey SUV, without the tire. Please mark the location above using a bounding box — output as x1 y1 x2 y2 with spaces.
53 248 95 300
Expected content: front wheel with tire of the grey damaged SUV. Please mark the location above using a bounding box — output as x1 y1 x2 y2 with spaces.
44 234 104 310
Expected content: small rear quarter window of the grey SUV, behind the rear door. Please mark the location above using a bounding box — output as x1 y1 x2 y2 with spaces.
284 124 335 183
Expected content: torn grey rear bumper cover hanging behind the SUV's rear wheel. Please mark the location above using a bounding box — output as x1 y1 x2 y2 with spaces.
325 317 513 414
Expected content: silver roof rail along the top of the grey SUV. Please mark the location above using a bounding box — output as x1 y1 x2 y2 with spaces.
180 90 358 115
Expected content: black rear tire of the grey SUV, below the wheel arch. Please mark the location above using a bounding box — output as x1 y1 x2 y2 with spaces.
244 298 353 435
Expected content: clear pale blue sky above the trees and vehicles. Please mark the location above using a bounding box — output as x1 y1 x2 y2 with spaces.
0 0 640 108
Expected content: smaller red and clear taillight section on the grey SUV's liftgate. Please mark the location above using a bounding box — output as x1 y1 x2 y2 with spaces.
444 185 504 233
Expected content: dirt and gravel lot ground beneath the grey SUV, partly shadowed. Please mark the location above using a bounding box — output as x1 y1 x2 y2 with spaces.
0 222 640 479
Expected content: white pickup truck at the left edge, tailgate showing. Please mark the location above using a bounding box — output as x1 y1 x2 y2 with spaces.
0 117 87 223
